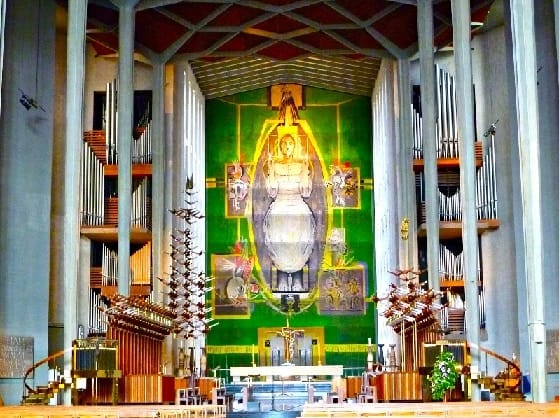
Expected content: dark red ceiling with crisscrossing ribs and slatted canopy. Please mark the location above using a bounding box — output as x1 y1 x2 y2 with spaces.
57 0 493 98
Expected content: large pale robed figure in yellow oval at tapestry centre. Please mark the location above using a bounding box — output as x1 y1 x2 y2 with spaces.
251 99 328 298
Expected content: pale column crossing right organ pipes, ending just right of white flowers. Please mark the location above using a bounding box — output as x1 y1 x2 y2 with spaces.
452 0 481 401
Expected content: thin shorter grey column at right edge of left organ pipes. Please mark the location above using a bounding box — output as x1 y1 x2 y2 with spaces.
151 63 165 302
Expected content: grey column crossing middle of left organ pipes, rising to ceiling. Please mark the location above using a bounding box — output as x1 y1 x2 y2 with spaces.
117 3 134 295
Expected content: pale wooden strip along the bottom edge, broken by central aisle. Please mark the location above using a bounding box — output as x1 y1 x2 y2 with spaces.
0 402 559 418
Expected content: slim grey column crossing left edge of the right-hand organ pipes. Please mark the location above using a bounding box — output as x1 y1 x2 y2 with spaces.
417 0 440 291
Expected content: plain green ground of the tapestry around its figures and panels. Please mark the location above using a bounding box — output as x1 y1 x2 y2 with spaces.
206 87 375 378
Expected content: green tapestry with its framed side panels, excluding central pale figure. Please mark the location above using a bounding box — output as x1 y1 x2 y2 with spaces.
206 87 375 374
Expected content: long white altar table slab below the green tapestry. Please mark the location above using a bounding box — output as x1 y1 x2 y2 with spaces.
230 364 344 382
